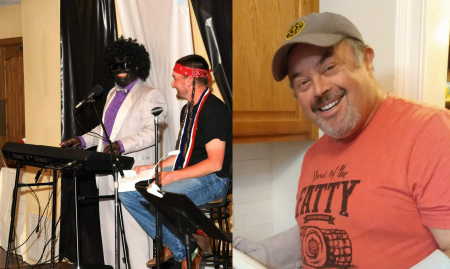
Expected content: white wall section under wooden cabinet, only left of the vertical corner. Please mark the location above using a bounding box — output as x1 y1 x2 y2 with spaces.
233 143 274 241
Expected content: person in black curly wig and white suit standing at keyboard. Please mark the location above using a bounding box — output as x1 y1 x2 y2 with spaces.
60 38 167 268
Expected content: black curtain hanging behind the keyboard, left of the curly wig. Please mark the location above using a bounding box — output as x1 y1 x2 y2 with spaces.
59 0 117 264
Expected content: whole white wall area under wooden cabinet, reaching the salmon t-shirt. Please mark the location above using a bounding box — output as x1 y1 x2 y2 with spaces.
233 141 314 241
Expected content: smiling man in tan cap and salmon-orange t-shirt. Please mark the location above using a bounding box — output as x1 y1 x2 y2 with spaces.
272 13 450 268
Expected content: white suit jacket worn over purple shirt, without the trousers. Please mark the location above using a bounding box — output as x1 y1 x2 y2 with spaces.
83 79 167 166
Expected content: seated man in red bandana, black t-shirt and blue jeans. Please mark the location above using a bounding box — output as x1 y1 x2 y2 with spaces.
119 55 232 268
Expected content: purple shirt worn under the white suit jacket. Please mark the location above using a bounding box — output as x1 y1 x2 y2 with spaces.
78 79 138 152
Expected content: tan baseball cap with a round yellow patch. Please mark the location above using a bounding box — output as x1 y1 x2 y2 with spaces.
272 12 364 81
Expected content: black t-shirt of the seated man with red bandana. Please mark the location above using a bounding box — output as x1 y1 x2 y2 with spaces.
180 93 233 178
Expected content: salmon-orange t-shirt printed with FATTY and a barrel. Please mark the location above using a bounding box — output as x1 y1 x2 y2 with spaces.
295 95 450 269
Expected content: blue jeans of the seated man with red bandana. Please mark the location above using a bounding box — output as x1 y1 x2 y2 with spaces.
119 167 227 262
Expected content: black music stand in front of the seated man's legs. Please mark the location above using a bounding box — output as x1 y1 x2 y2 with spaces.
135 181 232 269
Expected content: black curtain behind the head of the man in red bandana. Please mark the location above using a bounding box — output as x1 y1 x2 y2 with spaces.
191 0 233 112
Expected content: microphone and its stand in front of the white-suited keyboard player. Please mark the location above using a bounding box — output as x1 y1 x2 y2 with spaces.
89 97 125 269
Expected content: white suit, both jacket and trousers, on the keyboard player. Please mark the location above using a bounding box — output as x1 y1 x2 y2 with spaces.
79 79 167 268
